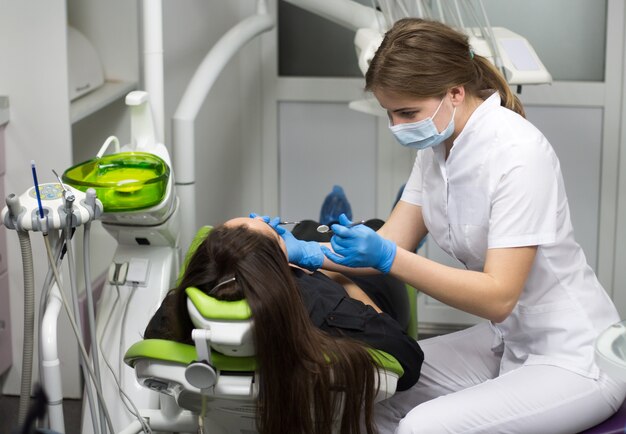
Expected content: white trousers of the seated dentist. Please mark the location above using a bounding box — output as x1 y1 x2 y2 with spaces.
375 323 626 434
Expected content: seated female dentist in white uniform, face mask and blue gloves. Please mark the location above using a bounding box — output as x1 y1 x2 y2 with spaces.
277 19 626 434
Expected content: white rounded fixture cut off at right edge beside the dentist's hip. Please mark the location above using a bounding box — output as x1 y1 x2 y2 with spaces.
596 321 626 381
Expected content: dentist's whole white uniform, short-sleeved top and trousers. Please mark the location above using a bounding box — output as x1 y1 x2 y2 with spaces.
376 93 626 434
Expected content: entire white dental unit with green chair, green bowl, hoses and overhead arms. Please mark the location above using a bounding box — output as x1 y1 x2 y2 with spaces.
12 0 626 434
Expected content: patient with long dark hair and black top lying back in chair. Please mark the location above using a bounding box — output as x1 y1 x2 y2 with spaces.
144 218 423 434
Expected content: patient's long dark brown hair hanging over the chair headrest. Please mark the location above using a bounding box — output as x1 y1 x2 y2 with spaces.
166 226 377 434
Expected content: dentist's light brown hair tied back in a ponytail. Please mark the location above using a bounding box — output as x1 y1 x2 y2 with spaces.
365 18 525 116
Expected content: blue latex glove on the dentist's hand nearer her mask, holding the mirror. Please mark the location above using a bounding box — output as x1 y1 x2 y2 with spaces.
322 214 396 273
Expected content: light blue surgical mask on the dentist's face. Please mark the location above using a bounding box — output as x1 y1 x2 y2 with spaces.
389 97 456 150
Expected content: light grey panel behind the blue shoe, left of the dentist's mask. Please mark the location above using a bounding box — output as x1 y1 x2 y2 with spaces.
278 102 377 221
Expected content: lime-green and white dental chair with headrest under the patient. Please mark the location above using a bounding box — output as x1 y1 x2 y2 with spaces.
122 226 404 434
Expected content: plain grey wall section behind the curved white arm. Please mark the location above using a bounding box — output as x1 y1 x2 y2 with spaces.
164 0 262 229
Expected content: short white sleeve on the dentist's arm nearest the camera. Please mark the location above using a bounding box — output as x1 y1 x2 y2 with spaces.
488 139 560 248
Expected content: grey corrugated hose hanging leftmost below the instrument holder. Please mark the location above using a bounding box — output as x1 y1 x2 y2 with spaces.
17 230 35 426
